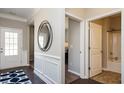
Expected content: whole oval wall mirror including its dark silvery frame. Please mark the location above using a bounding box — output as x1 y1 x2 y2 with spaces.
38 20 53 51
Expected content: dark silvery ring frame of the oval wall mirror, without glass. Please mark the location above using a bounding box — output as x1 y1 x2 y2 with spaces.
37 20 53 52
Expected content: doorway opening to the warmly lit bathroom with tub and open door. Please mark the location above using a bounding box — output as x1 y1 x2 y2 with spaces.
89 13 121 84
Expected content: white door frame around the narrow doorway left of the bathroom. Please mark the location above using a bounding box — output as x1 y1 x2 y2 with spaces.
62 12 85 83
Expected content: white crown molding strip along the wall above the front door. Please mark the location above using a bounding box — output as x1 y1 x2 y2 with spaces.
0 13 27 22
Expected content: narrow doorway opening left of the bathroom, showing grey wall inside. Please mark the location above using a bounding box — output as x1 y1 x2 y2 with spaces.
65 16 80 84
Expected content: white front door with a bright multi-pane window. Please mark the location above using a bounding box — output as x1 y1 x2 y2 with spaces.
0 28 22 69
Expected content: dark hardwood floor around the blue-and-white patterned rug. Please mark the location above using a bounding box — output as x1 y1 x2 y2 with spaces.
0 66 46 84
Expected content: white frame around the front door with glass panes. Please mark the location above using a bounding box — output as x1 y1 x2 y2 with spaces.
0 26 23 70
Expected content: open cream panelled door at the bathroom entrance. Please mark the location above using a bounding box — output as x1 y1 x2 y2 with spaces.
90 22 102 77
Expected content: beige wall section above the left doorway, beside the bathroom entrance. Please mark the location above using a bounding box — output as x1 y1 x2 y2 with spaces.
65 8 85 18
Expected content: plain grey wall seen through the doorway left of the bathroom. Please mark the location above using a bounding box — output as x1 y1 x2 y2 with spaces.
68 19 80 74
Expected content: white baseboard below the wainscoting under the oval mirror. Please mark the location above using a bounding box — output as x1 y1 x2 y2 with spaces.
34 68 57 84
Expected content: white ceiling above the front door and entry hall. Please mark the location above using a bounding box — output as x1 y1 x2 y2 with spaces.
0 8 38 19
